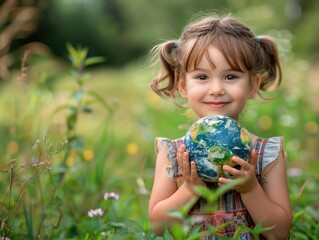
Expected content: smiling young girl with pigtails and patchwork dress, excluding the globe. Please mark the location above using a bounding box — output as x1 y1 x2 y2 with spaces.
149 16 292 240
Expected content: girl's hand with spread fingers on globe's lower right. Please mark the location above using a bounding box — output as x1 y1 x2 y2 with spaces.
218 150 258 193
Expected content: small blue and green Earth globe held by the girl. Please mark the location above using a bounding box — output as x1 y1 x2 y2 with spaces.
184 115 252 182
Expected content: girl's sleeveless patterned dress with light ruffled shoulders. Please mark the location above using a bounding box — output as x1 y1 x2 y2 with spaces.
155 137 285 240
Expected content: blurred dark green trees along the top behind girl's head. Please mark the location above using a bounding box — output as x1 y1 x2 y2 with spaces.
8 0 319 66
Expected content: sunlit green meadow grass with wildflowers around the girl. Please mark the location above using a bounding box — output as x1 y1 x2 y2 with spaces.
0 49 319 239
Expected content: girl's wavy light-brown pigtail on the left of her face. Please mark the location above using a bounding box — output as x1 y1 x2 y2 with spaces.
151 41 179 98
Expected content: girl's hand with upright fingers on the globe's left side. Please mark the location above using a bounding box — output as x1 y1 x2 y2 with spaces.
176 144 206 191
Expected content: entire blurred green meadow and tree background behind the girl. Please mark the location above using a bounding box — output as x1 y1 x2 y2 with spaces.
0 0 319 239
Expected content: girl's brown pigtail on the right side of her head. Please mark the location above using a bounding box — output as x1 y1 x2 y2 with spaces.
256 36 282 90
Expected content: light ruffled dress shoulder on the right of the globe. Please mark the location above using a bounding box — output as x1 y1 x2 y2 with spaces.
253 136 286 182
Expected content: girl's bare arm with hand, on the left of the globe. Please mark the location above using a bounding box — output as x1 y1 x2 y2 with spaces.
148 143 202 235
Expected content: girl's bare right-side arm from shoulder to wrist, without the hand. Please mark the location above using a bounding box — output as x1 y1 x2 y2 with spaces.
241 149 292 240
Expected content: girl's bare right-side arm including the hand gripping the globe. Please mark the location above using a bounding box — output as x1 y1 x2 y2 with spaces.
220 151 292 240
